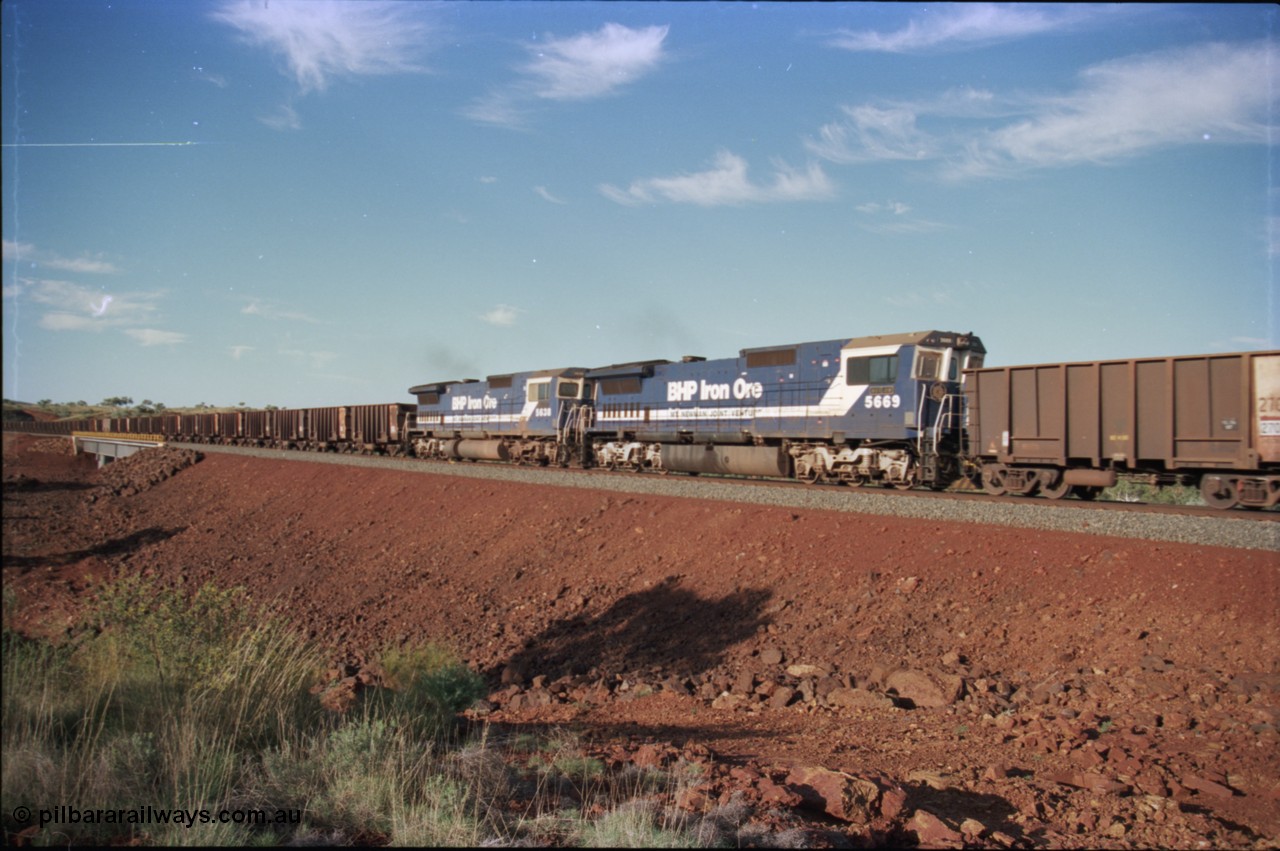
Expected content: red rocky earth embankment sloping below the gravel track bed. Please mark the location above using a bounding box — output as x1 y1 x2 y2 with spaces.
4 434 1280 848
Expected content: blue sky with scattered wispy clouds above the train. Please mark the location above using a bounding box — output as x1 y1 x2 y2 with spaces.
0 0 1280 407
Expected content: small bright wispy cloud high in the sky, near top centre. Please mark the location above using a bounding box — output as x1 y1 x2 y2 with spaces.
462 23 668 127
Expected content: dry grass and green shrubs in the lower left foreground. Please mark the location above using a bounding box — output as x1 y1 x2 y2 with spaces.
0 577 798 847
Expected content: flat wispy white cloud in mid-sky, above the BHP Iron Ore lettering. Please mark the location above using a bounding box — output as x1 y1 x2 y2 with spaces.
600 151 835 207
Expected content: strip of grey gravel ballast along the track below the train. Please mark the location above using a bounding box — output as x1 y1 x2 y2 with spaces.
170 444 1280 552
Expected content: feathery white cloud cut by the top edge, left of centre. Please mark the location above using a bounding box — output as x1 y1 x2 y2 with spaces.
212 0 430 92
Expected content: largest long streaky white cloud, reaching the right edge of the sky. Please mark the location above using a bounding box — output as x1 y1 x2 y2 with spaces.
806 42 1280 178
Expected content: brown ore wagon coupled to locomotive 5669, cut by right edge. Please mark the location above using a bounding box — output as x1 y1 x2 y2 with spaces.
965 351 1280 508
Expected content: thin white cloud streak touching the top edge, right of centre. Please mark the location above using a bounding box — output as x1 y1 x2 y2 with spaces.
828 3 1108 52
